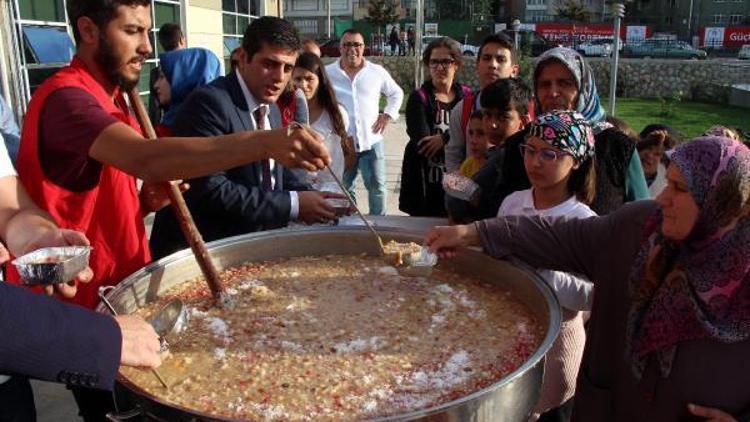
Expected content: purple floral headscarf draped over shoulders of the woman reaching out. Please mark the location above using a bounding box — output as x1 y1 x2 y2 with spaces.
627 137 750 377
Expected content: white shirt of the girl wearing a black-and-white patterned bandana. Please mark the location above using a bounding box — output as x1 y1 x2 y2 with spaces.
497 189 596 311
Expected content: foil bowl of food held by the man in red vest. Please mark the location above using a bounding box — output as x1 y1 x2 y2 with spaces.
13 246 91 285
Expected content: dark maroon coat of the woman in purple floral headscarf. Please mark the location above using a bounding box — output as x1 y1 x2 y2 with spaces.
476 201 750 422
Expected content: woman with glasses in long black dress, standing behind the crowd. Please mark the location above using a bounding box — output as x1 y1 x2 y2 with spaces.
398 37 471 216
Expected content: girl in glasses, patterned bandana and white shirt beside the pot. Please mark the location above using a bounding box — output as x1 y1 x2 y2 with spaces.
497 111 596 418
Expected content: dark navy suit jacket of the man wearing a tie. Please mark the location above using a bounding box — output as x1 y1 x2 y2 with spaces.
150 72 310 259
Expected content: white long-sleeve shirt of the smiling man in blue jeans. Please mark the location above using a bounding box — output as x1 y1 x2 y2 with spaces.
326 59 404 152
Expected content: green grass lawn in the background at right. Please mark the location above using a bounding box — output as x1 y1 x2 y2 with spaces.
602 98 750 138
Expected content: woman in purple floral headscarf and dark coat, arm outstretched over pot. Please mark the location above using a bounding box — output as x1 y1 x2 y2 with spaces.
426 137 750 422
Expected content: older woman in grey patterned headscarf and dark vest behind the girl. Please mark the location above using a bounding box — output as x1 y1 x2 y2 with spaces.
534 47 650 215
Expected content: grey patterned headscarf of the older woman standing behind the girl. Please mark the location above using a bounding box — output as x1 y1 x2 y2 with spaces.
534 47 612 133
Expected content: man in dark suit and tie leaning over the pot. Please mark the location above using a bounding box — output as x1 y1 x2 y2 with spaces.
150 16 342 259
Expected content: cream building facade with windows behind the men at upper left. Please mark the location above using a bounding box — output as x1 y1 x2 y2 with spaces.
0 0 283 123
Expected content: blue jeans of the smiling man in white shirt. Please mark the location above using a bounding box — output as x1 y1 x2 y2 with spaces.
344 141 385 215
